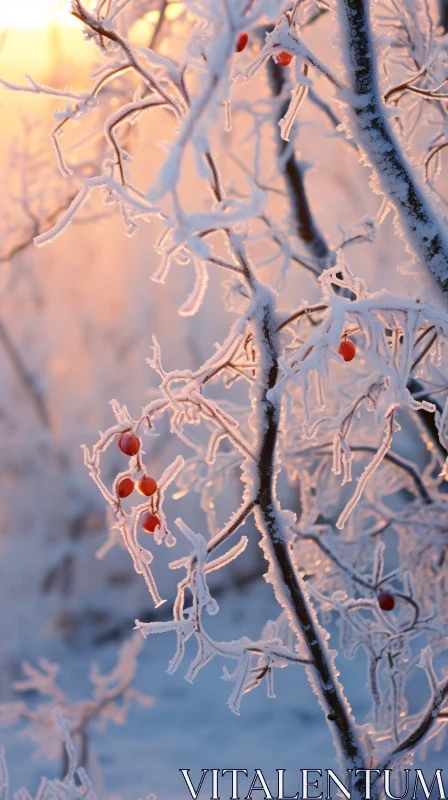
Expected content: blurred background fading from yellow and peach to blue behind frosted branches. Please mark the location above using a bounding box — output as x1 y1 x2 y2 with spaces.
0 0 439 799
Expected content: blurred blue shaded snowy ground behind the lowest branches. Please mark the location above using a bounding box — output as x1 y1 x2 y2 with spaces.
1 583 440 800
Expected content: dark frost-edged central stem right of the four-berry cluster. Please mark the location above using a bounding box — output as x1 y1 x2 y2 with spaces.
248 276 364 767
